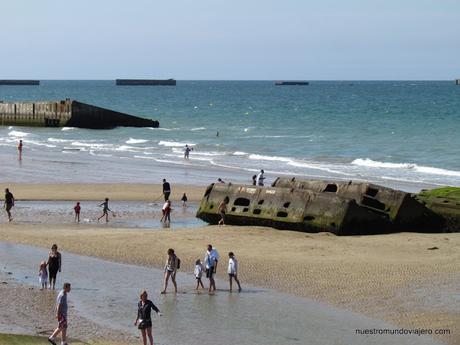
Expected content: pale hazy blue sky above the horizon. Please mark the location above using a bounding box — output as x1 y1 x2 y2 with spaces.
0 0 460 80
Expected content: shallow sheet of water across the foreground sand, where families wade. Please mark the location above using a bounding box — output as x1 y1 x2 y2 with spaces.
0 242 441 345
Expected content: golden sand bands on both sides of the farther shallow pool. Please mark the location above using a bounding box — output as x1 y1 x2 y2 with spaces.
0 185 460 344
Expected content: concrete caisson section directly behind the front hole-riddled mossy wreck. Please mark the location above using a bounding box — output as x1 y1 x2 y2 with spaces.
272 178 443 231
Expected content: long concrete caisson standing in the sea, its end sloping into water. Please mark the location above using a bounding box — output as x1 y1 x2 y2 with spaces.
0 99 159 129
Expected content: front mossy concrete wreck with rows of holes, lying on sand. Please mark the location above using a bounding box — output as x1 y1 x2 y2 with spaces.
197 184 390 235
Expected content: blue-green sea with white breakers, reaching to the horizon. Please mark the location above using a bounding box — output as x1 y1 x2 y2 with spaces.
0 80 460 191
